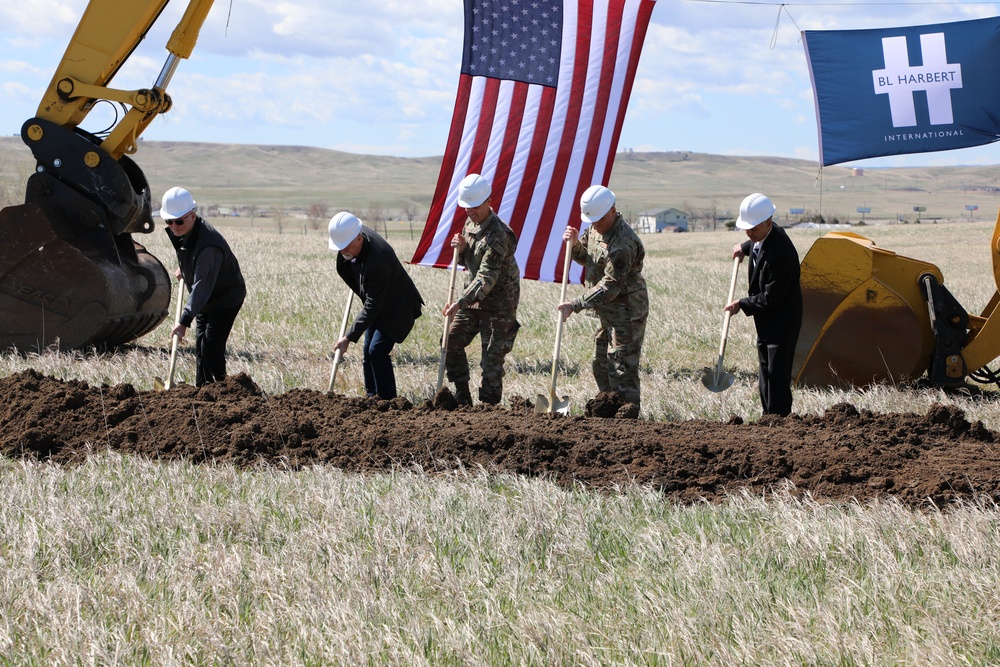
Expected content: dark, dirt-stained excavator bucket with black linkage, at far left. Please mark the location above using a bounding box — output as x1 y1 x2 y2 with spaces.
0 119 171 351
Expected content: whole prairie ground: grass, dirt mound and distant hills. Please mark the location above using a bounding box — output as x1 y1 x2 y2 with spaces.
0 142 1000 665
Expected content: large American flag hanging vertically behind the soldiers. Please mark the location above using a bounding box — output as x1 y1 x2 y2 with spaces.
411 0 655 282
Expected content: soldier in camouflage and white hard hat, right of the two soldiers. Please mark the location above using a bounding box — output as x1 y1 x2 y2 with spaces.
559 185 649 404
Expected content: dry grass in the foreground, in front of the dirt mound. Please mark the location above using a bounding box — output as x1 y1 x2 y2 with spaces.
0 455 1000 665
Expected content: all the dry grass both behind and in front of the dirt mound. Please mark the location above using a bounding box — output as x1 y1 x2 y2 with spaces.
0 223 1000 665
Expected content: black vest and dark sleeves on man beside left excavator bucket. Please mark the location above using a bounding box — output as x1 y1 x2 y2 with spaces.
167 216 247 327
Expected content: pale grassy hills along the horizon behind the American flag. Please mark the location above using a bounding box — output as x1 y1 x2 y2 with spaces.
0 137 1000 227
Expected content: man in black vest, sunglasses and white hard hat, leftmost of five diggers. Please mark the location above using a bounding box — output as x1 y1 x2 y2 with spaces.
160 187 247 387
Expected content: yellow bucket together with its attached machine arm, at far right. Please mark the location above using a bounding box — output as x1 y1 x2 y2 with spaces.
792 207 1000 387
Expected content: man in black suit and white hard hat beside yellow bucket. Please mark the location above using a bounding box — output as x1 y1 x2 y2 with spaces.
726 192 802 416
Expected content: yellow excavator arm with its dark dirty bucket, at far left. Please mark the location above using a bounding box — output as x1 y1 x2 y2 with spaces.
0 0 212 350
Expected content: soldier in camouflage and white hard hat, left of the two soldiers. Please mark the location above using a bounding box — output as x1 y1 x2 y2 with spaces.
444 174 521 405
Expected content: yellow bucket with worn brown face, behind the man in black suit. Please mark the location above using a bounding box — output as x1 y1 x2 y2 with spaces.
792 232 943 387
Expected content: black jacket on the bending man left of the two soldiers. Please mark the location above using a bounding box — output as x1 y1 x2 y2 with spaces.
337 227 424 343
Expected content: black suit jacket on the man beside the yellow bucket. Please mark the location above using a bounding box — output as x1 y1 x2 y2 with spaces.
740 224 802 343
